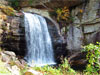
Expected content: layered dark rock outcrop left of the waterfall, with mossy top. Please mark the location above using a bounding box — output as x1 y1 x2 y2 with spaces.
0 4 25 55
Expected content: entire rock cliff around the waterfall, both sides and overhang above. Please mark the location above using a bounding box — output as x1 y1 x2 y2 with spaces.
0 0 100 62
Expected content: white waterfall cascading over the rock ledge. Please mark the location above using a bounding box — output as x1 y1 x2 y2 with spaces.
24 13 55 66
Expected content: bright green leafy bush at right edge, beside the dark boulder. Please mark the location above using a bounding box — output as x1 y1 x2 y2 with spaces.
84 42 100 74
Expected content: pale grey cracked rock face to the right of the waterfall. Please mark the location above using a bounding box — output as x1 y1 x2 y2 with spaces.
67 0 100 52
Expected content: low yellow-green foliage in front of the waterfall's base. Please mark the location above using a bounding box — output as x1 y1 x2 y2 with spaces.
33 59 76 75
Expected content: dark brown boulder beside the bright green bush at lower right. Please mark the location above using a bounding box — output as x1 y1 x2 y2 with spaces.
68 52 87 69
